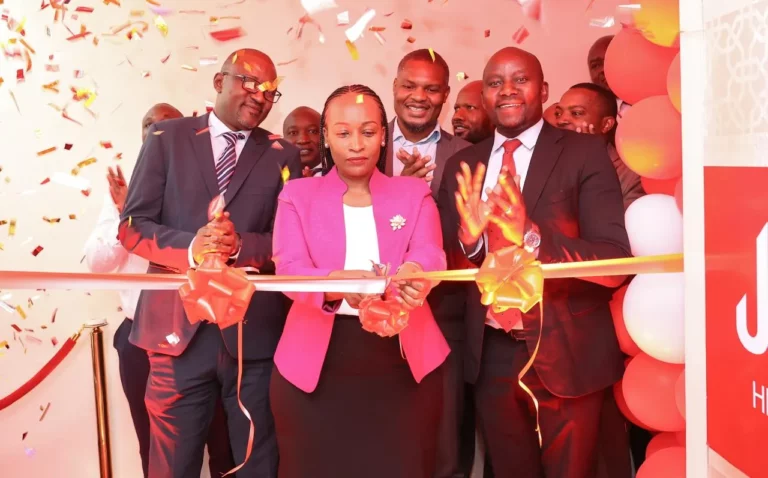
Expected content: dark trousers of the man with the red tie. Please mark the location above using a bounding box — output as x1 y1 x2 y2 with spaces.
475 327 630 478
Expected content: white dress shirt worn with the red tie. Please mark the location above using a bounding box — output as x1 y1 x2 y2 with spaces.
459 119 544 329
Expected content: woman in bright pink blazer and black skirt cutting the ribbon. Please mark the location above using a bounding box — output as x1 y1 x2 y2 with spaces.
270 85 449 478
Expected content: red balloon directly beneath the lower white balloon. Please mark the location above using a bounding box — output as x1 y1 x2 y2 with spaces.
621 352 685 432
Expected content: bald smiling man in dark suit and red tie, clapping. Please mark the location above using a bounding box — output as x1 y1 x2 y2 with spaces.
438 48 630 478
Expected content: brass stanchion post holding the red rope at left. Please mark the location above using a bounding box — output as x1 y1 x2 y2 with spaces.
86 320 112 478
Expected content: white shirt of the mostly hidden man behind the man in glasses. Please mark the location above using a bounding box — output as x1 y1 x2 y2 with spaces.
85 194 149 319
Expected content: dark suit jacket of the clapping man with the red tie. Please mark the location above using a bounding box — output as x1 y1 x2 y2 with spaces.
438 123 630 397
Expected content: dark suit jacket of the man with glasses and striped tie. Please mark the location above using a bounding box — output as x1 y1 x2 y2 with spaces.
120 115 301 359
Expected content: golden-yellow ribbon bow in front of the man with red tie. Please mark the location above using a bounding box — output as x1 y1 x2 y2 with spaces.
476 246 544 313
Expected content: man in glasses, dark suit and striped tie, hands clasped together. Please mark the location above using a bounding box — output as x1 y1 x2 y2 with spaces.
120 49 301 478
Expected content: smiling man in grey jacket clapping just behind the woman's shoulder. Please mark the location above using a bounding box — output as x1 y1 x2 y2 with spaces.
386 49 474 478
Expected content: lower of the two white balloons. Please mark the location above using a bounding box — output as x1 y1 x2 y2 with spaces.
623 272 685 364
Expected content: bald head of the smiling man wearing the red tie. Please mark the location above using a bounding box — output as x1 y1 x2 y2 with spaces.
483 47 549 138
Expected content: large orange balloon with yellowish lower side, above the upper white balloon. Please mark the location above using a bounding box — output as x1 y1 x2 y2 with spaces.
614 95 683 179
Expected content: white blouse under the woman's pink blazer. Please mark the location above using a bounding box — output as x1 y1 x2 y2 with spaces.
336 204 380 315
